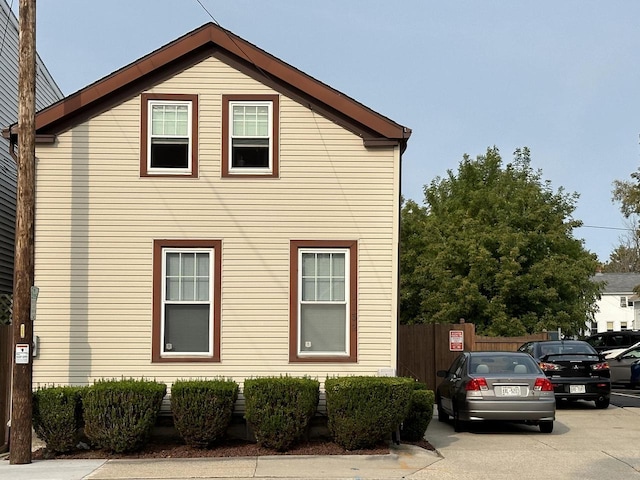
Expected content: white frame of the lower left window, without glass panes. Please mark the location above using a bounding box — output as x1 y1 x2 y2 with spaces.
160 247 215 357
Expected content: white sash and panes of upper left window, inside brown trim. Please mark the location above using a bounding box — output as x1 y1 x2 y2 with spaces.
147 100 193 174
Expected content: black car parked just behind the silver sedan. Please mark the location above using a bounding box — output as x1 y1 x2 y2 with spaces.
518 340 611 408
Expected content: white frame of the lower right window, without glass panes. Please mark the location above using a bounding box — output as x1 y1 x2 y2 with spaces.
297 247 351 357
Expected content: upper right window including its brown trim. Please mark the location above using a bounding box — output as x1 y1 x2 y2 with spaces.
222 95 279 177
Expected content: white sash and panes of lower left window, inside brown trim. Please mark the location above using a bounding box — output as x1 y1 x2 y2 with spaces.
160 248 214 357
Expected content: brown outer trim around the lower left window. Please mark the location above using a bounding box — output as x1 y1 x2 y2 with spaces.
151 240 222 363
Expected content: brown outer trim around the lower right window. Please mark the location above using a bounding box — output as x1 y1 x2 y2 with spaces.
289 240 358 363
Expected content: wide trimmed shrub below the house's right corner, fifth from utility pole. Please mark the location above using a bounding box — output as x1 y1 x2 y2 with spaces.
325 377 414 450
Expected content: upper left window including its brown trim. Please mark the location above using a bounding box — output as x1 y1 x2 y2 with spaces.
140 93 198 177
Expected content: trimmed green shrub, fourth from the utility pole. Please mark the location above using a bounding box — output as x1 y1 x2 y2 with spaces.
244 377 320 451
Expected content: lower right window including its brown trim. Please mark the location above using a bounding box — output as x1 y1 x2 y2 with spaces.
290 241 357 361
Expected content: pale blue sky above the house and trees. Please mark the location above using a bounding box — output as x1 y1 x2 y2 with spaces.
7 0 640 261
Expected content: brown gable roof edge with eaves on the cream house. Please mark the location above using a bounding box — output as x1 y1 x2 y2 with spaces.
2 23 411 150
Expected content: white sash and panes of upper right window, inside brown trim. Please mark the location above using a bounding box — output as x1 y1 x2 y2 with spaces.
228 100 273 174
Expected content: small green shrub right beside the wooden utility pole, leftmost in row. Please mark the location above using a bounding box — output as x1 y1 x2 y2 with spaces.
33 387 84 453
